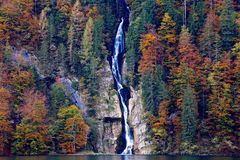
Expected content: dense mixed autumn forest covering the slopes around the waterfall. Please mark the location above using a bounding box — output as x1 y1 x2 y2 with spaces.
0 0 240 155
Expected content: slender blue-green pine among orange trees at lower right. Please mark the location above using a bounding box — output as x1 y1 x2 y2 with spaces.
181 85 197 143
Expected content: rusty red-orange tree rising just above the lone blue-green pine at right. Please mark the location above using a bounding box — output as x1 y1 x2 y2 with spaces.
170 26 204 107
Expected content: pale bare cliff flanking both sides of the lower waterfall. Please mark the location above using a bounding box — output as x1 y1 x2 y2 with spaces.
91 56 152 154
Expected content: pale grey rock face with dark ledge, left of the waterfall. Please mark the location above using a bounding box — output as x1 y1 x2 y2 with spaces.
96 62 122 153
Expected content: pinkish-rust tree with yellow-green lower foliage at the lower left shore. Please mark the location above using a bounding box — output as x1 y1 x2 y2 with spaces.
13 90 48 155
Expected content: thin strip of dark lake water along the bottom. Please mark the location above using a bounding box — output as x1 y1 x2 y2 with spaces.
0 155 240 160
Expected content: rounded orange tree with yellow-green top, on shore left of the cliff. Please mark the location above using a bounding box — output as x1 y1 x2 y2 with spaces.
55 105 88 153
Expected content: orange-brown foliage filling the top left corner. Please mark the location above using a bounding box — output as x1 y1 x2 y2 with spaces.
0 0 40 49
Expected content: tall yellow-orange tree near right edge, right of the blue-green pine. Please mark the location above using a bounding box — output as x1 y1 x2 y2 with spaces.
208 56 234 150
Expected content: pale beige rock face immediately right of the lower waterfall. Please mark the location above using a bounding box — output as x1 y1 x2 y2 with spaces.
129 87 153 154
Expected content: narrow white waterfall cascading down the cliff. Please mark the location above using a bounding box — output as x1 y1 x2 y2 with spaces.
112 18 133 154
